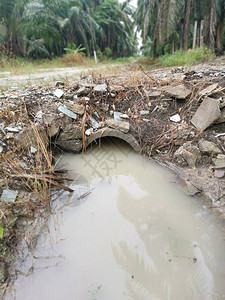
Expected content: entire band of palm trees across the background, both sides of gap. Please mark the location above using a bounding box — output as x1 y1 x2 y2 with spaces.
0 0 225 63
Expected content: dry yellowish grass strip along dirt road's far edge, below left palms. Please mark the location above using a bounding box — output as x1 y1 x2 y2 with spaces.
0 53 134 77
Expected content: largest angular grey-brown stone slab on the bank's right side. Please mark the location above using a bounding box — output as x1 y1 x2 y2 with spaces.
191 98 221 131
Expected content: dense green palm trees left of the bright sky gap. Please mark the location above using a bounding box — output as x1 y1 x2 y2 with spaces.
0 0 136 59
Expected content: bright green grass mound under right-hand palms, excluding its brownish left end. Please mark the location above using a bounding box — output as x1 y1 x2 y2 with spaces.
158 48 214 67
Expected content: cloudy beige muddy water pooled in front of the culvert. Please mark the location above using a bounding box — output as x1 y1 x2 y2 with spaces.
6 141 225 300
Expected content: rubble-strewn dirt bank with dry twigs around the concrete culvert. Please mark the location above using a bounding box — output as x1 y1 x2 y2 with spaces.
0 58 225 290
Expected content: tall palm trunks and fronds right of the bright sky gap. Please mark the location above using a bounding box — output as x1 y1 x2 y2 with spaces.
134 0 225 57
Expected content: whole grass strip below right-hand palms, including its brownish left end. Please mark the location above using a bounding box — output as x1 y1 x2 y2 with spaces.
138 48 214 67
